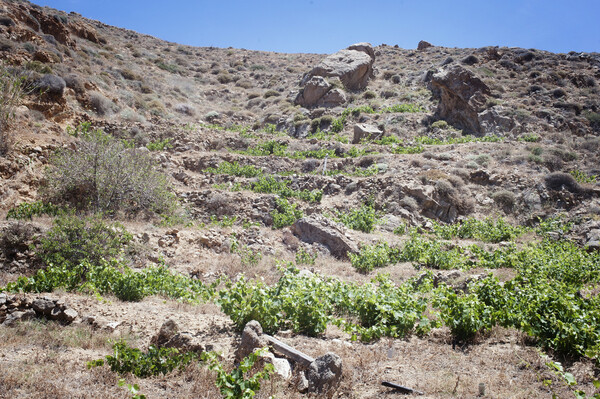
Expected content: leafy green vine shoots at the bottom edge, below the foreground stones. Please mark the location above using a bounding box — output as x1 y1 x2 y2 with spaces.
202 348 275 399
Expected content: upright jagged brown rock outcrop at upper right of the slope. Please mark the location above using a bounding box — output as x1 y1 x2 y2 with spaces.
431 65 490 134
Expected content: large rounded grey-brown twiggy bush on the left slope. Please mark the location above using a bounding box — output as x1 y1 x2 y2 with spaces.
43 130 176 214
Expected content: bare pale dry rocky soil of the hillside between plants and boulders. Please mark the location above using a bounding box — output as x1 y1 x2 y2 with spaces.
0 1 600 398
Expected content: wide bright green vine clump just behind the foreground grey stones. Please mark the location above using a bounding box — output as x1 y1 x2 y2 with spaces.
218 267 426 341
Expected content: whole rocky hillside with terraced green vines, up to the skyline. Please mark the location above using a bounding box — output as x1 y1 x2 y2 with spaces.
0 0 600 398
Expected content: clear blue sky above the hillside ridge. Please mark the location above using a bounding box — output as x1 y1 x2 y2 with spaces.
33 0 600 53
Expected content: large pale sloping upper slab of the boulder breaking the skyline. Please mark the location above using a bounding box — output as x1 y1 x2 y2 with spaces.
301 43 375 90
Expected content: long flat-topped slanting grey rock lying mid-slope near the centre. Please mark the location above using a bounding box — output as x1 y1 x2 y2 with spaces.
292 215 358 258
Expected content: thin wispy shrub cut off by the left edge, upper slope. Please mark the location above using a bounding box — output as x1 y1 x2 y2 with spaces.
0 65 23 155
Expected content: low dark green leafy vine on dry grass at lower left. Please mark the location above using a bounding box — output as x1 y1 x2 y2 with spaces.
87 340 198 378
